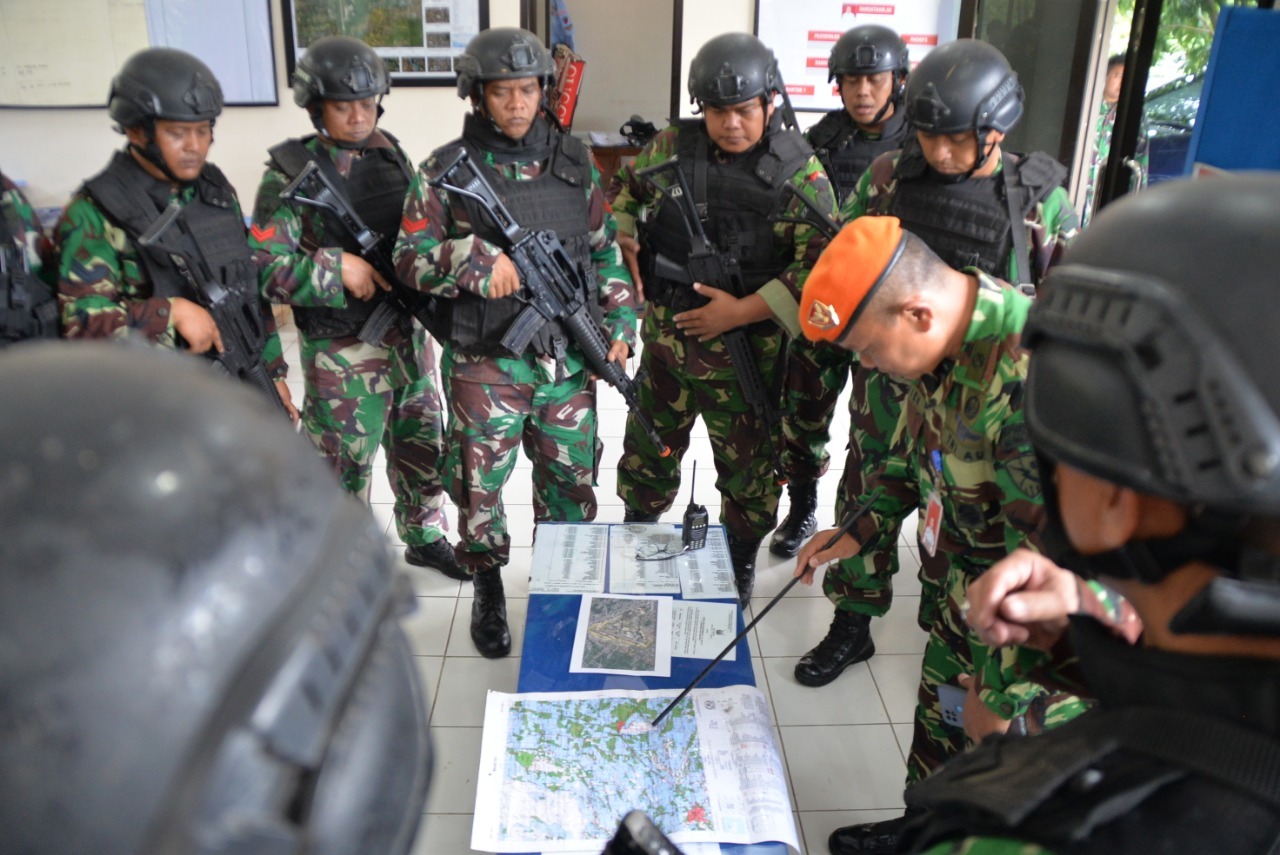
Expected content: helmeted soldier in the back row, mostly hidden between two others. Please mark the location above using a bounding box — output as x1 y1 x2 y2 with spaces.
769 24 910 563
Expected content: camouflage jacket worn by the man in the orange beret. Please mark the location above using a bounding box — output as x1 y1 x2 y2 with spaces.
854 270 1049 719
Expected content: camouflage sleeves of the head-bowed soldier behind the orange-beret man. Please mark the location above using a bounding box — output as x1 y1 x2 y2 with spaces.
840 152 1079 282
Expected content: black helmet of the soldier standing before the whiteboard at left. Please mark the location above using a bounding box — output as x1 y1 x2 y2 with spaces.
106 47 223 132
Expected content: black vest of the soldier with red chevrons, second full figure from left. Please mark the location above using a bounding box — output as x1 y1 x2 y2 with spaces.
271 131 413 338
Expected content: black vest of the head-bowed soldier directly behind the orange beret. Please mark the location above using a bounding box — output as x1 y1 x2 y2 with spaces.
884 145 1066 284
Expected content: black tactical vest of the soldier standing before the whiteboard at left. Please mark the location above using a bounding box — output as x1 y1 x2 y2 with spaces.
82 151 259 305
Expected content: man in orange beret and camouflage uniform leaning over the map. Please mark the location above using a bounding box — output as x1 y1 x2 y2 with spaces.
795 216 1066 855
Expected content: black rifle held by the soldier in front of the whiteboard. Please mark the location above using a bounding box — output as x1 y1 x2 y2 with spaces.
138 202 287 412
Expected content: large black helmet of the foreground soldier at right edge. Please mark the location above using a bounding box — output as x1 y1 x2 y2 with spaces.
1023 173 1280 634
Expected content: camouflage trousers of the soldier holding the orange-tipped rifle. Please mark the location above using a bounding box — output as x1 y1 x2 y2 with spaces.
444 371 602 572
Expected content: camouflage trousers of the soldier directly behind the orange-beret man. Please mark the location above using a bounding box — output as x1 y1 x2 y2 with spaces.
822 365 947 622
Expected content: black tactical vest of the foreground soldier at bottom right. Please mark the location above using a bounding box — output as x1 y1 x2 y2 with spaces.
900 618 1280 855
